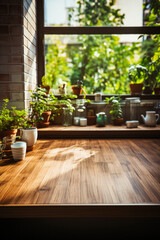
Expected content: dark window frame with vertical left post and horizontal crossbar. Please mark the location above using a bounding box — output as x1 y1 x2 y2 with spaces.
37 0 160 94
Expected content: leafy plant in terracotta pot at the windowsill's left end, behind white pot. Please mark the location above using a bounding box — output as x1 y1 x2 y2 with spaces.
30 87 51 128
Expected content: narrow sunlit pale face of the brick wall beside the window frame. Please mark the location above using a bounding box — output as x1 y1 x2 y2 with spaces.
23 0 37 108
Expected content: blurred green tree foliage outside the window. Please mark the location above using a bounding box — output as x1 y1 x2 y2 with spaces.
46 0 160 94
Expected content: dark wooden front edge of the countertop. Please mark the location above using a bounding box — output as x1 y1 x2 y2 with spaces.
0 204 160 219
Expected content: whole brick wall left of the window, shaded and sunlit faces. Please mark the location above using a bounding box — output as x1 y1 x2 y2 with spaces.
0 0 37 109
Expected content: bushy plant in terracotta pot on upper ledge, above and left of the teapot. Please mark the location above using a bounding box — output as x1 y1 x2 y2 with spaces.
128 64 148 95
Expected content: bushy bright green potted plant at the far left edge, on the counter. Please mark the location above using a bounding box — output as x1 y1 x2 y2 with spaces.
0 99 27 139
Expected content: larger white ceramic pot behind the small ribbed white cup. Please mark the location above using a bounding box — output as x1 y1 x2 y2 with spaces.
20 127 38 147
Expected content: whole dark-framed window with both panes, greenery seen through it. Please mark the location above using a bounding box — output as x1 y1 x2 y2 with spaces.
38 0 160 94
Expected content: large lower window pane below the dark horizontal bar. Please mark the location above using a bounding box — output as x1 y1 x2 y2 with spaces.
45 35 160 94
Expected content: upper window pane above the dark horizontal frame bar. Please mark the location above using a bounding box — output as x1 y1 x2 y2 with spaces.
44 0 144 26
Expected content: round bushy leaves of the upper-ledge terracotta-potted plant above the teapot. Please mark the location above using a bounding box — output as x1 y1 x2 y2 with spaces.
128 64 148 83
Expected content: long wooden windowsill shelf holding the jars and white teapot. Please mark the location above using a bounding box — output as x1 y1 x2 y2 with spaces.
38 125 160 138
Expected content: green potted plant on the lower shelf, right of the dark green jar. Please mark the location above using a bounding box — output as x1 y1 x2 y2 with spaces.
105 96 123 126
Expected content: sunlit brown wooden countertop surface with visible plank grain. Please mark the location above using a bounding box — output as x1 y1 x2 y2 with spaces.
0 139 160 204
